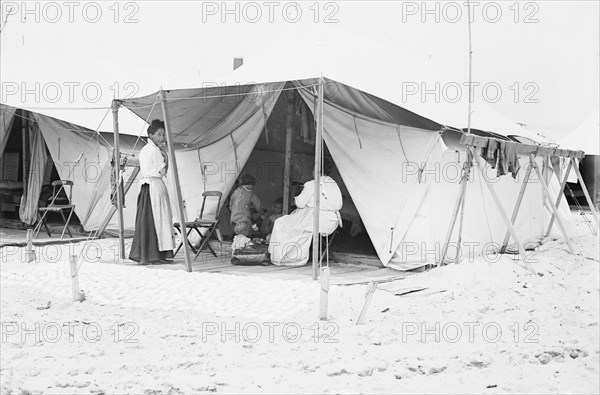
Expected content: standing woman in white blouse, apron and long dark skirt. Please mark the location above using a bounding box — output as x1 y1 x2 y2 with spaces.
129 119 174 265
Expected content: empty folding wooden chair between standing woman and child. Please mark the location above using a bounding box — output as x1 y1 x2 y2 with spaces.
173 191 223 259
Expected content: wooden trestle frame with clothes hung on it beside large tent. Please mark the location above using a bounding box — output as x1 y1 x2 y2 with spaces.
438 134 600 274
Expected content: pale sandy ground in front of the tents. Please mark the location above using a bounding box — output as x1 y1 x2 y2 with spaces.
0 213 600 394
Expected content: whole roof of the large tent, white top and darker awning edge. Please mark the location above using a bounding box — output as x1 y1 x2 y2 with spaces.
123 30 544 144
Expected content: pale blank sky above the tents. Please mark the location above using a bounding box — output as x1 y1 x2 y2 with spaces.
0 1 600 139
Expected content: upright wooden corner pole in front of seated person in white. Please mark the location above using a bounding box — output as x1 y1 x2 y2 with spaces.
312 77 323 280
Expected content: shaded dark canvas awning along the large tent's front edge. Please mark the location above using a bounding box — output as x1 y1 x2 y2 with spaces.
122 78 442 146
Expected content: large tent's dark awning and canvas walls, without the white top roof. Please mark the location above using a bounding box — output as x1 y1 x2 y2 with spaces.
119 78 568 270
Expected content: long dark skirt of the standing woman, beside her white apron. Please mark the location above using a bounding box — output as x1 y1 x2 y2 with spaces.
129 184 173 264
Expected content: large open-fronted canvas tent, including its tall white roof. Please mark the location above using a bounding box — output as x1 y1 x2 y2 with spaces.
108 32 568 269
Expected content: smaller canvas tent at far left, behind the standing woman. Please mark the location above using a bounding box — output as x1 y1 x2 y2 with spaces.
0 104 144 232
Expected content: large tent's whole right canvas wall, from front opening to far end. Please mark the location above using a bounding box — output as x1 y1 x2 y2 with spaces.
302 87 569 270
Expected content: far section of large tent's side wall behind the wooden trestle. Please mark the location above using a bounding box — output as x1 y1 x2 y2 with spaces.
389 149 571 270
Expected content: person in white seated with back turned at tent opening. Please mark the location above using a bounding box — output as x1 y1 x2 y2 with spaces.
269 162 343 266
